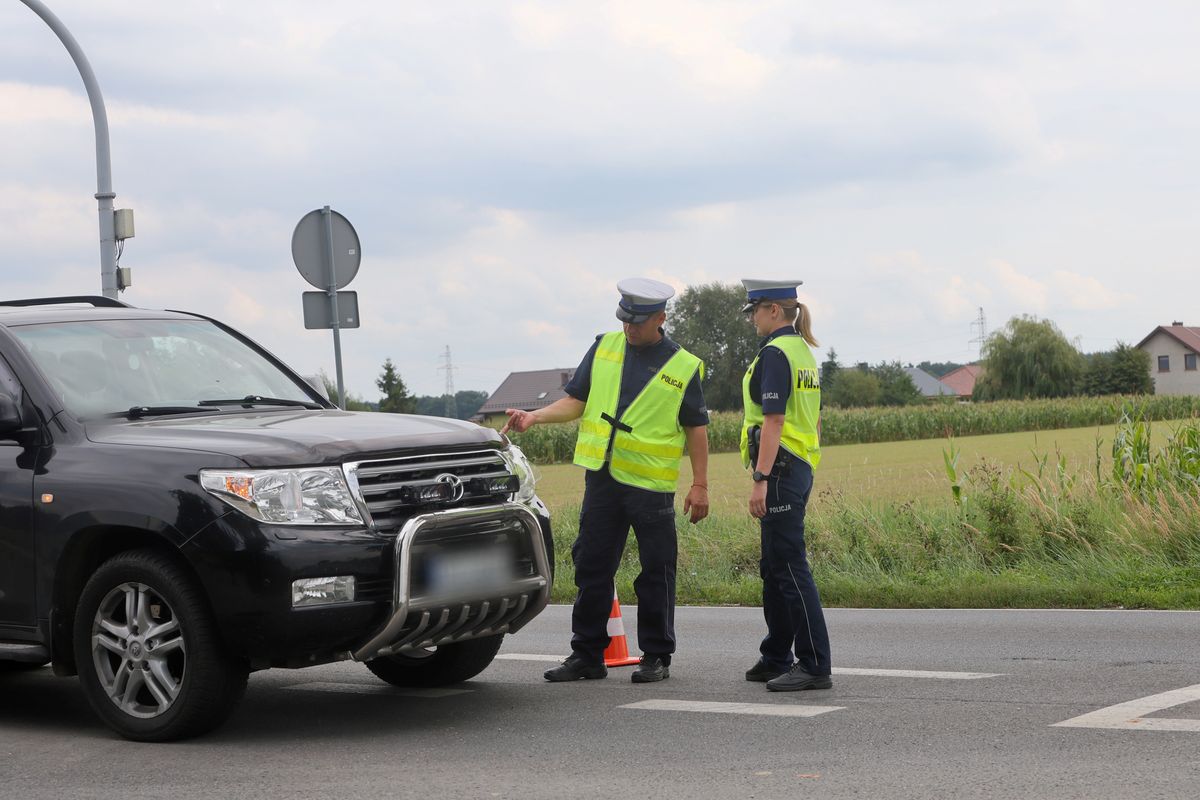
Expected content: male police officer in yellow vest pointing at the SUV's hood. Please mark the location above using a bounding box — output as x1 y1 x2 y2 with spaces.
502 278 708 684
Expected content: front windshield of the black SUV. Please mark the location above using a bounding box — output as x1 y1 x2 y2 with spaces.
10 319 313 419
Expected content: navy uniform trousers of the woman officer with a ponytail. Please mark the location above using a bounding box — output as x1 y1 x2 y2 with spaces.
758 457 830 675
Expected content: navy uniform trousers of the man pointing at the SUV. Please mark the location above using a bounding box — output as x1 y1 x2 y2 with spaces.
571 465 678 663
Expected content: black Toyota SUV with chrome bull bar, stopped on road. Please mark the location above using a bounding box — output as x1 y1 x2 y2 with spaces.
0 297 553 741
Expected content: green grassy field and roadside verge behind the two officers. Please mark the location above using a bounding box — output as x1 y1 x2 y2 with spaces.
538 423 1200 608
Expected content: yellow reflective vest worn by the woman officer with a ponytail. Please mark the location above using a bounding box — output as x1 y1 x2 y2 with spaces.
740 333 821 469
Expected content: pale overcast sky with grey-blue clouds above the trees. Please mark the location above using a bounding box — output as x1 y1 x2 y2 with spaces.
0 0 1200 399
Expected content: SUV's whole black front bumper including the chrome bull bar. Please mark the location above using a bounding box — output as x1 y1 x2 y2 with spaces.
182 499 553 669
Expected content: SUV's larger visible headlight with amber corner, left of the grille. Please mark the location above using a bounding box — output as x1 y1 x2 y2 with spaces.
200 467 362 525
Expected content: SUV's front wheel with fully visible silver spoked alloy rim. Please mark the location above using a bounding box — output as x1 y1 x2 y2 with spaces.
74 551 248 741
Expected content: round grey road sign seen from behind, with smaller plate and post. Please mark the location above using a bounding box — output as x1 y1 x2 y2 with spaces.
292 205 362 409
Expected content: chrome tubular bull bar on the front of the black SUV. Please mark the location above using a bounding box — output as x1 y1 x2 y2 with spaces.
350 503 552 661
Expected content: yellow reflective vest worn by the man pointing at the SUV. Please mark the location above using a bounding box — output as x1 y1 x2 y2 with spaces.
575 331 704 492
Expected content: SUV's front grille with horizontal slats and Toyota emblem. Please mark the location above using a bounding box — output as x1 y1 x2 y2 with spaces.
346 450 518 529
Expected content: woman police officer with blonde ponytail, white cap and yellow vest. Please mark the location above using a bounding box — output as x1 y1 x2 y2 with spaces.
742 279 833 692
